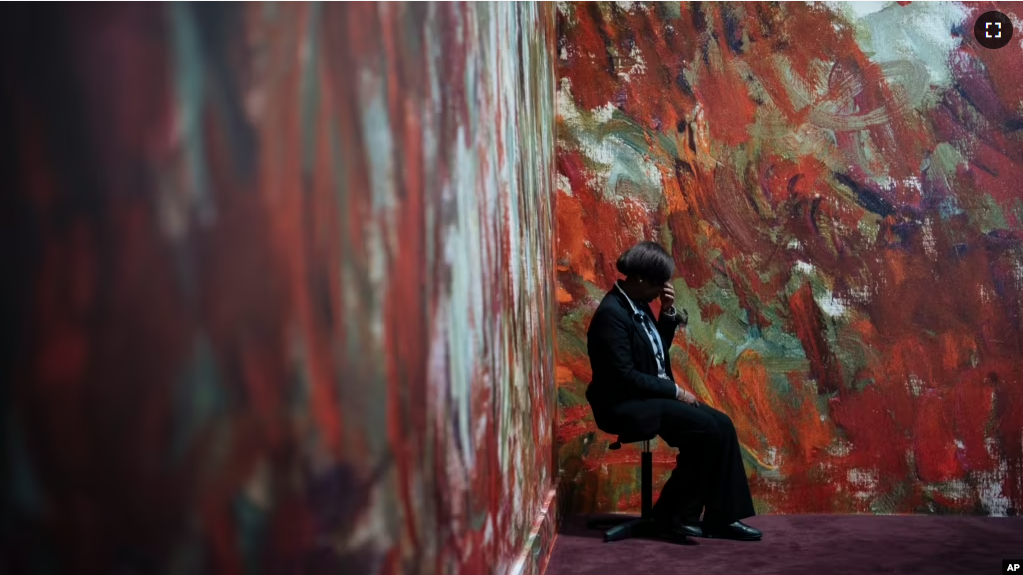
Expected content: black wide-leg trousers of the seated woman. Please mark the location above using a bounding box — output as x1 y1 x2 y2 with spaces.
612 399 756 525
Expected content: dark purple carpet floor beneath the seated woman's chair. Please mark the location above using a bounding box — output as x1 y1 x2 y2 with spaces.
546 516 1023 575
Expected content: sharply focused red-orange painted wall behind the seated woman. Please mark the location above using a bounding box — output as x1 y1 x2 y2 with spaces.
557 2 1023 516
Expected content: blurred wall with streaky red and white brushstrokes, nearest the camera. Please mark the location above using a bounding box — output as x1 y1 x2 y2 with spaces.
0 2 555 575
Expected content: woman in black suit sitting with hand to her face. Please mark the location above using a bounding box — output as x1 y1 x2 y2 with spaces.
586 241 761 541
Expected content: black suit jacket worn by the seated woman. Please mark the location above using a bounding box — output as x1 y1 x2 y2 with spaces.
586 288 685 433
